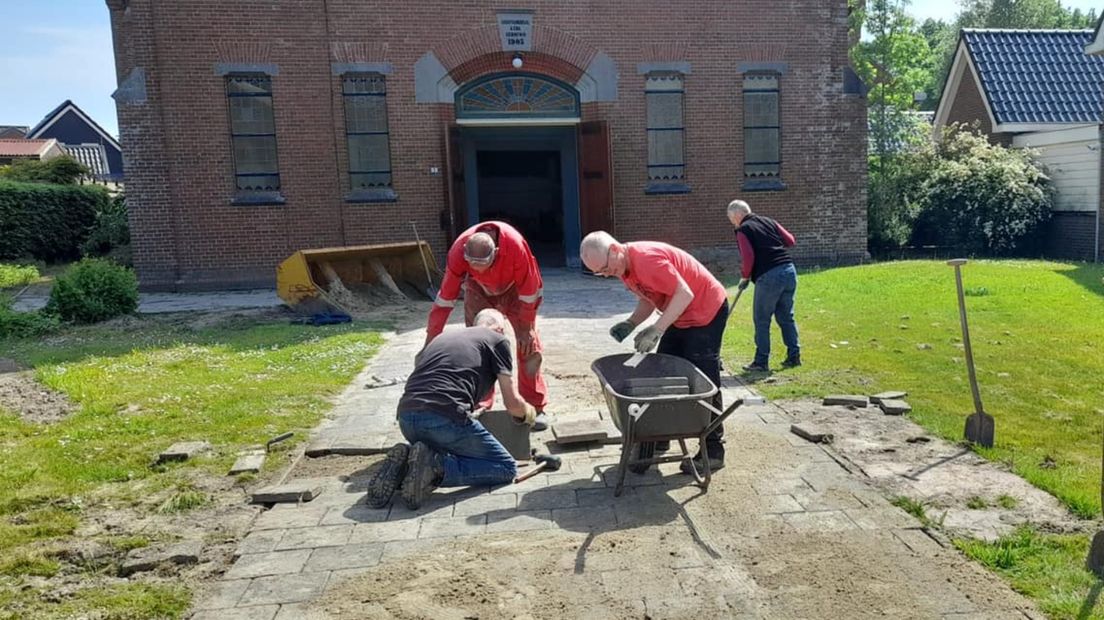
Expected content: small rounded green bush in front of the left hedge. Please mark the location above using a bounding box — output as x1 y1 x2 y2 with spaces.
46 258 138 323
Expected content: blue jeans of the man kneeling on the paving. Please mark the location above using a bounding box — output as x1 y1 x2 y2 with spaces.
399 411 518 487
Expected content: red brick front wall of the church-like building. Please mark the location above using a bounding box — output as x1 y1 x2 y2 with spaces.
109 0 866 289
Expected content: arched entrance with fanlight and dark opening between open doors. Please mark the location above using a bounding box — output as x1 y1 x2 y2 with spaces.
450 72 581 266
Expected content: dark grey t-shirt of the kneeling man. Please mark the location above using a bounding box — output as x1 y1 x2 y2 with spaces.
399 328 513 420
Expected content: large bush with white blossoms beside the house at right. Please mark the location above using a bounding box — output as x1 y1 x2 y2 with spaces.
912 126 1053 256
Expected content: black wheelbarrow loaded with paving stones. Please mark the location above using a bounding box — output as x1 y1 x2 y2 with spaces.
591 353 743 496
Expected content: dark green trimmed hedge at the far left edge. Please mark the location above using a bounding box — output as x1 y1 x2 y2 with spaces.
0 181 110 263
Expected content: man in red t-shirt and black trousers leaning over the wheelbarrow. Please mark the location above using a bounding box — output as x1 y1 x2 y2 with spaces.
580 231 729 473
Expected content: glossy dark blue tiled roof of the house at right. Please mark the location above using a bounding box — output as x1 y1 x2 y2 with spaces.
962 29 1104 124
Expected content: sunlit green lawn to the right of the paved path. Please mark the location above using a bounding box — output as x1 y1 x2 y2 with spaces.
723 260 1104 618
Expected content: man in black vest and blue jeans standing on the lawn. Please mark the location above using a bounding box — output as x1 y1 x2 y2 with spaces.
729 200 802 373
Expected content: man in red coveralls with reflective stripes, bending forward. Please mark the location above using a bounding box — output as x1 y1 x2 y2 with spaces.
425 222 548 430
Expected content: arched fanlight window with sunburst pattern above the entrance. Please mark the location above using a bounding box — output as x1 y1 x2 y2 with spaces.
456 73 580 118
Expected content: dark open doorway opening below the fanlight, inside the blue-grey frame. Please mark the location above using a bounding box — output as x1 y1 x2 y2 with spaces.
476 150 564 266
